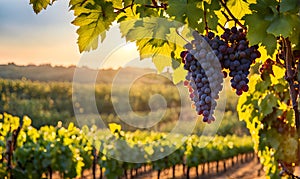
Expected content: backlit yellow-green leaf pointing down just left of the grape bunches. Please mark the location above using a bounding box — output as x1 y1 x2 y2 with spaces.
120 17 178 72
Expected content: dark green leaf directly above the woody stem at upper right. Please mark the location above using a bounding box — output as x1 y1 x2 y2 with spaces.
267 14 293 37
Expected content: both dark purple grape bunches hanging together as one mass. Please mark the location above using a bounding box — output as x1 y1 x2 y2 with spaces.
181 27 261 122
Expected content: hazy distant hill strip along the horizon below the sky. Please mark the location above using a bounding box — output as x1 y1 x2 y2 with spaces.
0 63 170 84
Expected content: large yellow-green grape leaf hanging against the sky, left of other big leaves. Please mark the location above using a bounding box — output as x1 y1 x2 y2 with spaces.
72 0 116 52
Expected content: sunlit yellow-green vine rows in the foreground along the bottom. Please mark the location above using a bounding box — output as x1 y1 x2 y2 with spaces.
0 113 254 178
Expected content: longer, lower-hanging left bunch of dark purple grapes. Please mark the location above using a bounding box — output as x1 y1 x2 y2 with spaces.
181 32 223 123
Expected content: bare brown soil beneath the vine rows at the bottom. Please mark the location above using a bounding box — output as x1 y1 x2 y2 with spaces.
53 154 300 179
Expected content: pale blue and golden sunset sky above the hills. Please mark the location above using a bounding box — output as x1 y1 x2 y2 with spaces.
0 0 151 68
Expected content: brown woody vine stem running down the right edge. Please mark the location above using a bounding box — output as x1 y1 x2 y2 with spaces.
281 37 300 164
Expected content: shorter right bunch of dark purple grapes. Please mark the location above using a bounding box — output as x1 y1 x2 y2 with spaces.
209 27 261 95
